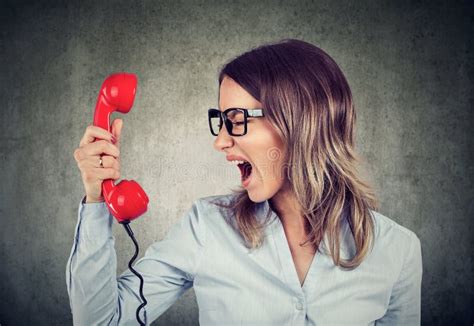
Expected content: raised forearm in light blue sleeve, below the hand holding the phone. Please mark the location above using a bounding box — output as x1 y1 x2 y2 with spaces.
66 197 123 325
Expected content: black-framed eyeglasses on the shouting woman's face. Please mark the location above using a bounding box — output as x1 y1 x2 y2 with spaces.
207 108 263 136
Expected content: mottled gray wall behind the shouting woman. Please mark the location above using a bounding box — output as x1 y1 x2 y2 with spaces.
0 1 474 325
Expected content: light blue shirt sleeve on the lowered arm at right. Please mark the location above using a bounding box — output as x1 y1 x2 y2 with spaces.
375 233 423 326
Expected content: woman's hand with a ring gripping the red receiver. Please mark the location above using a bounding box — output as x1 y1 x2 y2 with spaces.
74 119 123 203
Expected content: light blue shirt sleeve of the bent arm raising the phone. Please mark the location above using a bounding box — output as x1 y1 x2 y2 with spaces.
66 195 205 325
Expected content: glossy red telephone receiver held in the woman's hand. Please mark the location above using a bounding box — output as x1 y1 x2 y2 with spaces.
94 72 149 224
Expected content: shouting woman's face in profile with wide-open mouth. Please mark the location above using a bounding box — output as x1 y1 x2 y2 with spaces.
214 76 285 202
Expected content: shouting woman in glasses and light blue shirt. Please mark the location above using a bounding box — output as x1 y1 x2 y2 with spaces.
66 40 422 325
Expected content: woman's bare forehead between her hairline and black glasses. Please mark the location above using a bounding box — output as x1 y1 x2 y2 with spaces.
219 76 261 111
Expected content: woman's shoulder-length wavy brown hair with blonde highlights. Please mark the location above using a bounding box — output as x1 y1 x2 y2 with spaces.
213 39 378 269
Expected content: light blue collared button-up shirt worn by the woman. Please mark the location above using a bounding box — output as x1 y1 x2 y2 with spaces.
66 195 422 326
